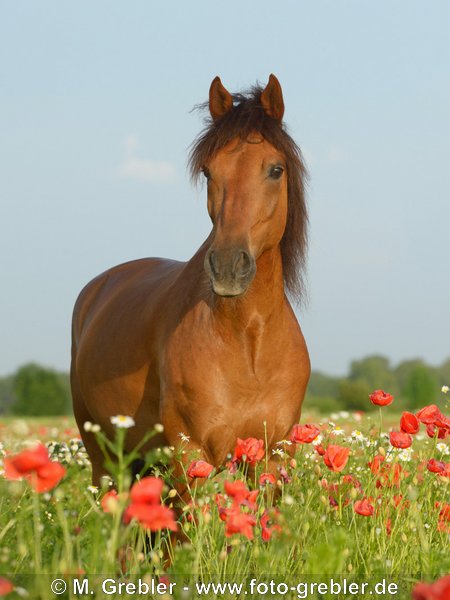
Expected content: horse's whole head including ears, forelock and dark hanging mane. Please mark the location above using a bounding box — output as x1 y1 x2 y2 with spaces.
191 75 307 297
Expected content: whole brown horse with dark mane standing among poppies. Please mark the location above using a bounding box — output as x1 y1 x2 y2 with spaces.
71 75 310 483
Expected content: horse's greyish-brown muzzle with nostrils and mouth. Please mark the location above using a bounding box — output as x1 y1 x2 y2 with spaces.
204 248 256 297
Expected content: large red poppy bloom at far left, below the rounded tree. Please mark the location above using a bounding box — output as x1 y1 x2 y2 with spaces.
4 444 66 494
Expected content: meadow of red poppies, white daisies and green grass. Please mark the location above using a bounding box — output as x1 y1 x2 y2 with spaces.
0 388 450 600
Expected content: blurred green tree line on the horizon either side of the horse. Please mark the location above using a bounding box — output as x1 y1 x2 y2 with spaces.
0 355 450 416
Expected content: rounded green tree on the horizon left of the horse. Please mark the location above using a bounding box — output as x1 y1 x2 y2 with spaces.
12 364 70 416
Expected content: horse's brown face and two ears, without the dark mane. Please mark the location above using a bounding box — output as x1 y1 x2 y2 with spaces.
202 75 288 296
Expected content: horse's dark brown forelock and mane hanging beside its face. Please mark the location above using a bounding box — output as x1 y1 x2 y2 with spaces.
189 86 308 300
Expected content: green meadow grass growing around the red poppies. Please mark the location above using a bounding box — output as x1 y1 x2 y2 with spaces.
0 398 450 599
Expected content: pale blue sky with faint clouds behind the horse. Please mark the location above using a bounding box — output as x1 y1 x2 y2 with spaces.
0 0 450 375
